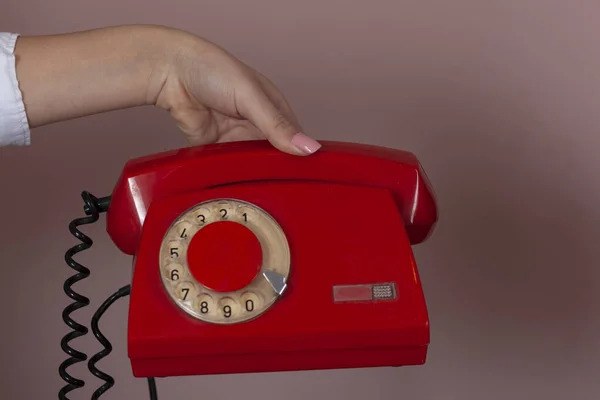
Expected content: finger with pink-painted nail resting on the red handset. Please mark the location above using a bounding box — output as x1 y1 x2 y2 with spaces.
238 89 321 155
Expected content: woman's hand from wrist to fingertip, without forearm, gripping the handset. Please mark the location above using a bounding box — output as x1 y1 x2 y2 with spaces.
150 27 319 154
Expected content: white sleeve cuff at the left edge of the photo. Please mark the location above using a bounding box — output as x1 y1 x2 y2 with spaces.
0 32 31 147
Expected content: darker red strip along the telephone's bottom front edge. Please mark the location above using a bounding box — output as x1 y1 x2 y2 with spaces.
131 346 427 378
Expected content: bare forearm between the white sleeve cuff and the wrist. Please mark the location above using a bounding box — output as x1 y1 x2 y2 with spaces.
15 26 172 128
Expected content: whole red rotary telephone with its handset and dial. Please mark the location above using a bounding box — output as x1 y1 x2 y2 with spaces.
62 141 438 398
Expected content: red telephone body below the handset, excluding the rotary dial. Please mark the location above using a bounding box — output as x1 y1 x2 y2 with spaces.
128 182 429 377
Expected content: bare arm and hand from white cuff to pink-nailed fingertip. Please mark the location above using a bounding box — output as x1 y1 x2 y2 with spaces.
15 25 320 155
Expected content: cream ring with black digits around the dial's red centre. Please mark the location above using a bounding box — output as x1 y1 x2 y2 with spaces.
159 199 290 324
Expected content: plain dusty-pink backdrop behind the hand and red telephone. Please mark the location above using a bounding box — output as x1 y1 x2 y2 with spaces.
0 0 600 400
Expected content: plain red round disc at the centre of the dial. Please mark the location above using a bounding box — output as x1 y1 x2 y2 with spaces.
187 221 262 292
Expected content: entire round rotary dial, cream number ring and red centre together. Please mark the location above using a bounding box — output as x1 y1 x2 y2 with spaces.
159 199 290 324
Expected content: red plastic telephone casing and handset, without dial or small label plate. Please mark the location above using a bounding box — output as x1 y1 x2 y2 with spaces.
107 141 437 377
